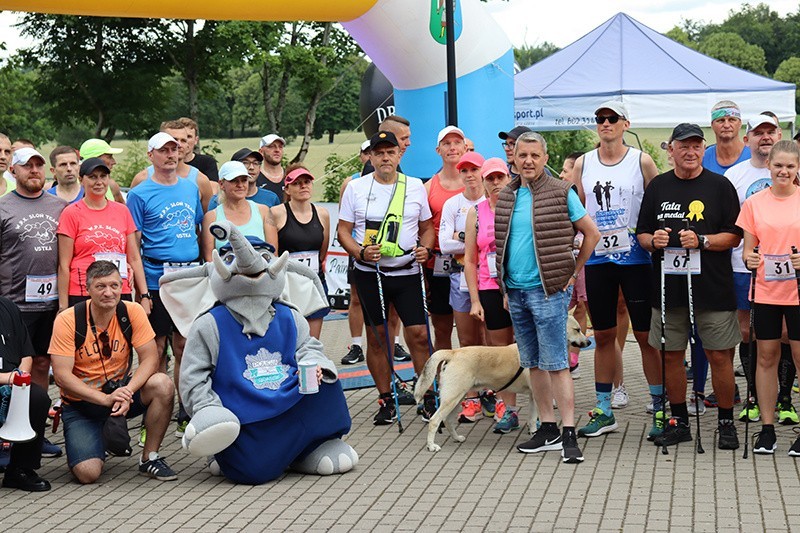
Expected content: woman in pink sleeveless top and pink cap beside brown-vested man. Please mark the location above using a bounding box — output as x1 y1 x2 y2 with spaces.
464 157 519 433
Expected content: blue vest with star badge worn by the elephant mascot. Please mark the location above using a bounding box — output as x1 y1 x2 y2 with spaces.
209 303 302 424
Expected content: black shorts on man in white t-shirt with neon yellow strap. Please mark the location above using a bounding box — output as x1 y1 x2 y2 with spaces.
353 269 424 326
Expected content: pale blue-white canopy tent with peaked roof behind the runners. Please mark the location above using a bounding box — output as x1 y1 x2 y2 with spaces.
514 13 796 131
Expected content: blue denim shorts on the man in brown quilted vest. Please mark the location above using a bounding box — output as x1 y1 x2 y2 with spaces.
508 286 572 372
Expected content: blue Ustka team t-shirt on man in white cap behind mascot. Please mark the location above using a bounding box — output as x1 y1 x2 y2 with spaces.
127 179 203 290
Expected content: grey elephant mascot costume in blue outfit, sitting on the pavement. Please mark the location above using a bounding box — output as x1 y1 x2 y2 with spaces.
160 221 358 484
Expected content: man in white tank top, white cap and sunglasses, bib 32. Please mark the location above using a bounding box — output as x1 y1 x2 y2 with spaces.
575 100 665 439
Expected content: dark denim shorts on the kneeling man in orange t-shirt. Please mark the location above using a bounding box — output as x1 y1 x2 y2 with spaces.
61 391 145 468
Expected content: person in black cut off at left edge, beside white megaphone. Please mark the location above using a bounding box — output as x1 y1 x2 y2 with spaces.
0 296 50 492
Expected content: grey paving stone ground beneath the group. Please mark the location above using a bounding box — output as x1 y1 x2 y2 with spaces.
0 320 800 533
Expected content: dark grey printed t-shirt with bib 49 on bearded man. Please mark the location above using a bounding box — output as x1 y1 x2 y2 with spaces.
0 192 67 312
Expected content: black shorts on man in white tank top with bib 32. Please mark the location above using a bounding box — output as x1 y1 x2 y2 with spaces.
584 263 653 331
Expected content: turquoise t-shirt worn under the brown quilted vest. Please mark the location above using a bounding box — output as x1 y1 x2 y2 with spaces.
504 187 586 289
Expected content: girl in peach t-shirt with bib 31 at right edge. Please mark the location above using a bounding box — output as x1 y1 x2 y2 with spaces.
736 141 800 457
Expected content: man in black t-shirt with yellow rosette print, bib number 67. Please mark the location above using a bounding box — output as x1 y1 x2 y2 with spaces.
636 124 742 450
